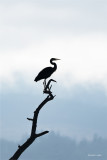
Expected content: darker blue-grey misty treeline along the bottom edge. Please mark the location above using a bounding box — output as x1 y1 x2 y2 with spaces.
0 132 107 160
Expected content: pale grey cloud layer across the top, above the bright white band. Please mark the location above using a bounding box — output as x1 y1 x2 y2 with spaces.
0 1 107 49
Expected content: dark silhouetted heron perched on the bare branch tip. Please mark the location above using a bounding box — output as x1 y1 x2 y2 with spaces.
34 58 60 86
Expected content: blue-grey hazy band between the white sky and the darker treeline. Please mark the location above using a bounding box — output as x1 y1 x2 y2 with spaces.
0 84 107 141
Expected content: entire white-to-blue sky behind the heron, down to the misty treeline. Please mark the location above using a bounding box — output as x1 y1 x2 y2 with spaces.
0 0 107 141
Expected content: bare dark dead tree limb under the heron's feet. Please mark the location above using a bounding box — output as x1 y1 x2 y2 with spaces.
9 79 56 160
